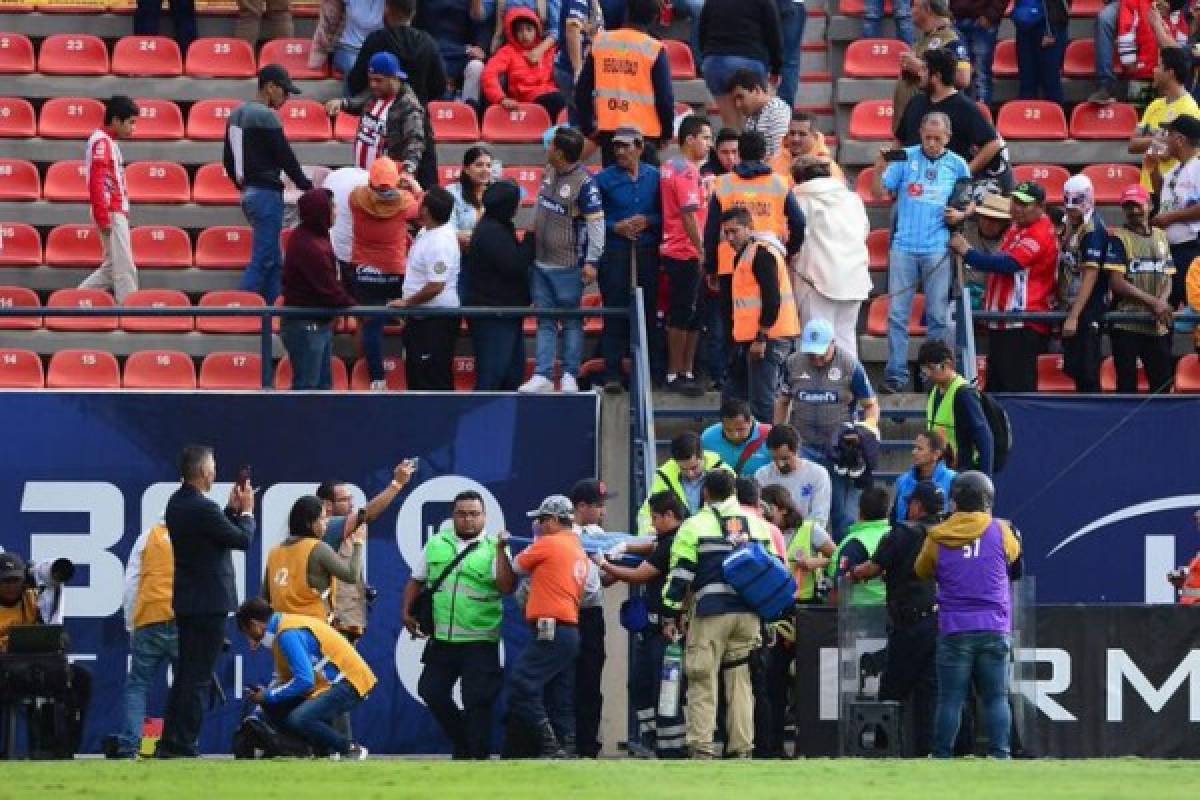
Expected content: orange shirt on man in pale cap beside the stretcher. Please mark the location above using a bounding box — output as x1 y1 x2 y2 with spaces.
516 530 588 625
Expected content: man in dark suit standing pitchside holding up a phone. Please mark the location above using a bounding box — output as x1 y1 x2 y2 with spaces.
158 445 254 758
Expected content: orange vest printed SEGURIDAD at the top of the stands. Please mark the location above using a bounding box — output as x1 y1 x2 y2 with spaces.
592 28 662 139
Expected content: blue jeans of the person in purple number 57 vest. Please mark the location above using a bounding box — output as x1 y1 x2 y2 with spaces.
934 633 1013 758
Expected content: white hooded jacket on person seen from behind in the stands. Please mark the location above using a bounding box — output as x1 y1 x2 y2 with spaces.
794 178 871 302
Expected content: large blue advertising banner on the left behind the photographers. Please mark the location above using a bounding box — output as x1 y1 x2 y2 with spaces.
0 392 599 753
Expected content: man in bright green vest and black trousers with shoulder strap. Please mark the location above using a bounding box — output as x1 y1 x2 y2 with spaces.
404 491 516 760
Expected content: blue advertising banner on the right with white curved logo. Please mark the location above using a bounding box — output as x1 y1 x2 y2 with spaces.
996 396 1200 603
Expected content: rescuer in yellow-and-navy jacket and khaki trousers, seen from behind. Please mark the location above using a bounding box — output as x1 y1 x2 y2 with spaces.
662 469 784 759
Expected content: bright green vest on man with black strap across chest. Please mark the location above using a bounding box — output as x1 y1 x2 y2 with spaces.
425 529 504 642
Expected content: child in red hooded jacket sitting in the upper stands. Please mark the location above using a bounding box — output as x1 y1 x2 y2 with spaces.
484 8 566 121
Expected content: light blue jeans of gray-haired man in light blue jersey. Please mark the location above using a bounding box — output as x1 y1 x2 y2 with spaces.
883 249 954 386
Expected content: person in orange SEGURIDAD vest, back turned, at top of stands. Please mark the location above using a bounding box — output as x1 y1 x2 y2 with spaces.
575 0 674 167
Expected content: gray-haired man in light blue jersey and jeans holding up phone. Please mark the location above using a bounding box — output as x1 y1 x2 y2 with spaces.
872 112 971 393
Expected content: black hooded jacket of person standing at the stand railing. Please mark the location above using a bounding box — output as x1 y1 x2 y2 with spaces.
462 181 534 306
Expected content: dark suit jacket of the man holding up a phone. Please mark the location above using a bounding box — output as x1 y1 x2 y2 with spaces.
164 485 254 616
